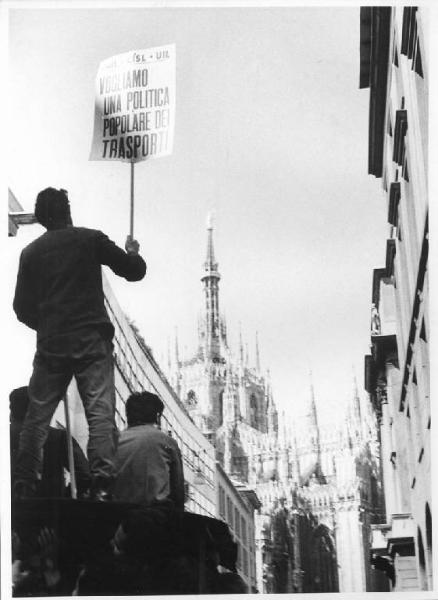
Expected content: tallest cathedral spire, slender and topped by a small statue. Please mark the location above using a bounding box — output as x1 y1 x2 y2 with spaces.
201 215 220 358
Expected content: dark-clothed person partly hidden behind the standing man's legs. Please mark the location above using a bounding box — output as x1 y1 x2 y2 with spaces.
9 386 91 498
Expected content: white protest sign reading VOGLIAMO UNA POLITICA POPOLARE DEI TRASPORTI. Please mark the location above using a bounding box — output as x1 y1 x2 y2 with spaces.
90 44 175 163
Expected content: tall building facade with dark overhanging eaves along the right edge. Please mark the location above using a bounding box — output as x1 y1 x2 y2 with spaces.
360 6 433 591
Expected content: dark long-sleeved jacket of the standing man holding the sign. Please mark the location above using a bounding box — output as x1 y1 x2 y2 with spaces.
13 227 146 341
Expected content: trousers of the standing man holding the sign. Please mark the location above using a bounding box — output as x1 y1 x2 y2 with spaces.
15 328 118 488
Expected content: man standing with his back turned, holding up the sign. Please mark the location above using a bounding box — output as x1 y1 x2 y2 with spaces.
13 188 146 500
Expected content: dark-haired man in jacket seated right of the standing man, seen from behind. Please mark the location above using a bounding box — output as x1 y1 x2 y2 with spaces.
113 392 184 554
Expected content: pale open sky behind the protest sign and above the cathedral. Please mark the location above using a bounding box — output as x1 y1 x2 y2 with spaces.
6 7 400 426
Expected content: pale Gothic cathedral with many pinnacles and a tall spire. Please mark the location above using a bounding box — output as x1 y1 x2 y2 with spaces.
171 222 386 593
